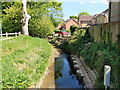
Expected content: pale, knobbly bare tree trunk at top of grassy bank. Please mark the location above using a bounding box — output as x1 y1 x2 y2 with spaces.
21 0 31 35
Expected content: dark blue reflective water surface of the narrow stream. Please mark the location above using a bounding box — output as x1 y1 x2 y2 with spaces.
55 54 83 88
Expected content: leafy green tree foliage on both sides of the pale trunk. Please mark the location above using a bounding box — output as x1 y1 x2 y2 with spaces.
2 2 62 38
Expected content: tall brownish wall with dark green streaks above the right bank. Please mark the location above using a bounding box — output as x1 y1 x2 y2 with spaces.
88 21 120 43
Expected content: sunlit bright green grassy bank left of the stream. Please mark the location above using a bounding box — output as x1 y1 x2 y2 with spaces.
2 36 52 88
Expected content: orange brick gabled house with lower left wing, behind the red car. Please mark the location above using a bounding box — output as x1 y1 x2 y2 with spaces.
56 19 78 30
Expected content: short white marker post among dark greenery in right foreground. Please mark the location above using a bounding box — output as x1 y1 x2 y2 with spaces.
104 65 111 90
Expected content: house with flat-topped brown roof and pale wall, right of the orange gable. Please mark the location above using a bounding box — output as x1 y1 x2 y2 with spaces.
79 15 93 28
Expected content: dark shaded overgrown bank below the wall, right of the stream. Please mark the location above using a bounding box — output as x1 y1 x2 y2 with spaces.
61 30 120 88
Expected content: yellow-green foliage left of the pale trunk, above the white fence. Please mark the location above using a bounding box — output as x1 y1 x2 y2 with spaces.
2 3 22 33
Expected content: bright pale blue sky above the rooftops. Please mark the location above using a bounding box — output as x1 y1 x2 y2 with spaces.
57 0 109 20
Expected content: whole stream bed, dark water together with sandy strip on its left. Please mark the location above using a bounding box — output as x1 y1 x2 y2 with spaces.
40 47 84 89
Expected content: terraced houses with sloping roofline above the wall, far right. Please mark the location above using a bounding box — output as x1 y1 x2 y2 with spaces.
91 9 109 25
